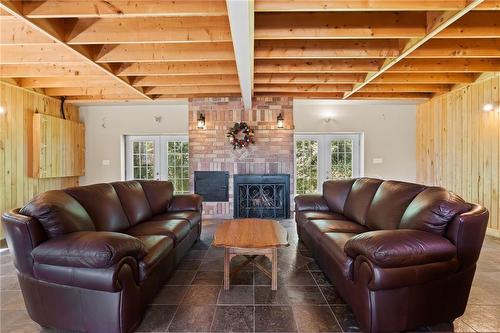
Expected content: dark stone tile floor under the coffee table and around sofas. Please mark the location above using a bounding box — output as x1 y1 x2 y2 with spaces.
0 220 500 332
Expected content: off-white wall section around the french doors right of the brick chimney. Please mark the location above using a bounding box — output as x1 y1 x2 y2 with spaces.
293 100 416 182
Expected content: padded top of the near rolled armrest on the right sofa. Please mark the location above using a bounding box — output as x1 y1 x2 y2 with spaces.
344 229 457 268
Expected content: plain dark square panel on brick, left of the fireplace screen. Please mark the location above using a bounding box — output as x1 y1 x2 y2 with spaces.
194 171 229 202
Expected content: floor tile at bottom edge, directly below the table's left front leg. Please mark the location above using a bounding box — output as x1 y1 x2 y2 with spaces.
211 305 254 332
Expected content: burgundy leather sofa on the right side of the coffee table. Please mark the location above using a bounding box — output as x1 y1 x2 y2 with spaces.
295 178 488 332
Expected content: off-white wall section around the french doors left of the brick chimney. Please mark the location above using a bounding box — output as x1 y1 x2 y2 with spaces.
80 100 188 185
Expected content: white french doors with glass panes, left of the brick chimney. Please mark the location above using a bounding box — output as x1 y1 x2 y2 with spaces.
125 135 189 193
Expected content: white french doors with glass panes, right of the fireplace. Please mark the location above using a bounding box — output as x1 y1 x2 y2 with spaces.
295 134 361 194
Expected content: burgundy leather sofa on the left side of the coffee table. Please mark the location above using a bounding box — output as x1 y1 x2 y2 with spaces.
2 181 202 333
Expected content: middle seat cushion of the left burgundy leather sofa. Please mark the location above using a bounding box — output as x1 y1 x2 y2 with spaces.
125 219 191 246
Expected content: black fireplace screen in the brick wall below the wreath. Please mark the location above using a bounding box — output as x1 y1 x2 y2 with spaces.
234 175 290 218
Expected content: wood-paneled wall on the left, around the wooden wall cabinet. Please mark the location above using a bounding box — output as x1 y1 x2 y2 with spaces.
0 82 79 238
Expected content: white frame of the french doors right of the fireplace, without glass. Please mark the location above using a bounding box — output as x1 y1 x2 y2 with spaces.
293 132 365 195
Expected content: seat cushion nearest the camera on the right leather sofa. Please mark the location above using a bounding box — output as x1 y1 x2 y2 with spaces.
318 232 356 280
